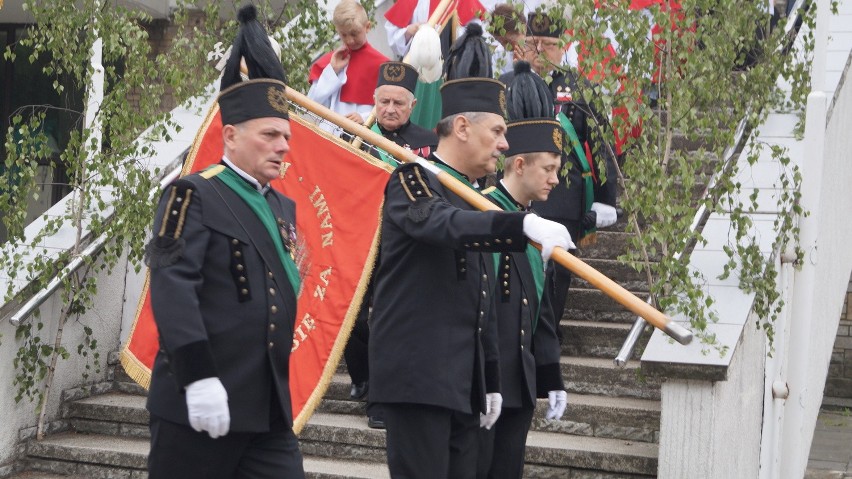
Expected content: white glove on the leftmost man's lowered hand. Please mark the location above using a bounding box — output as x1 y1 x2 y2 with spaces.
186 378 231 439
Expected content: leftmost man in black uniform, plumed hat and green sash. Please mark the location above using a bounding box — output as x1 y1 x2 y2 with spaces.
147 7 304 479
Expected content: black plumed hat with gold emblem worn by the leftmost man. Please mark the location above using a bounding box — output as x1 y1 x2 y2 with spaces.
217 5 289 125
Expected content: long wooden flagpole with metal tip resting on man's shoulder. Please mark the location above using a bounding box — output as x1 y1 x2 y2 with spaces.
287 88 692 344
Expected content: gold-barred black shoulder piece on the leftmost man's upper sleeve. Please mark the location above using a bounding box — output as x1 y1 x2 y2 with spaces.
145 178 195 268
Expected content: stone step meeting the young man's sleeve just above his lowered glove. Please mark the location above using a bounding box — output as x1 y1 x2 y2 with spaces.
560 356 660 399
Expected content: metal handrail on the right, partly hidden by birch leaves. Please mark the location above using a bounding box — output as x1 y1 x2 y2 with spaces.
613 0 807 368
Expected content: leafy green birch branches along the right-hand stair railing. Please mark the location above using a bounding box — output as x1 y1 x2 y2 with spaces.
524 0 814 354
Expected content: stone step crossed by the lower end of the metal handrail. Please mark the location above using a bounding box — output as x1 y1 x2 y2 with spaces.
559 320 651 359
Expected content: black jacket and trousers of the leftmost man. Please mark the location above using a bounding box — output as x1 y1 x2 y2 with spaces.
146 166 304 479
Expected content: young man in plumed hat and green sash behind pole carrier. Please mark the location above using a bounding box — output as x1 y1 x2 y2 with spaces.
477 118 568 479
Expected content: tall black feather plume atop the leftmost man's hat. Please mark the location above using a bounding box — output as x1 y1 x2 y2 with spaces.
219 5 287 91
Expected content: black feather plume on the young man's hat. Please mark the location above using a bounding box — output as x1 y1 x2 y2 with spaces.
506 61 554 120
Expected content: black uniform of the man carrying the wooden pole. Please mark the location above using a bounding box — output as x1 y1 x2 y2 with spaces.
370 155 526 477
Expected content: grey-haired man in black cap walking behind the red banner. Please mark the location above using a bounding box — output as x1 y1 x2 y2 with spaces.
343 62 438 429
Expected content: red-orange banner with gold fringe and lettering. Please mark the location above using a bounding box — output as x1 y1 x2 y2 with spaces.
121 106 391 434
